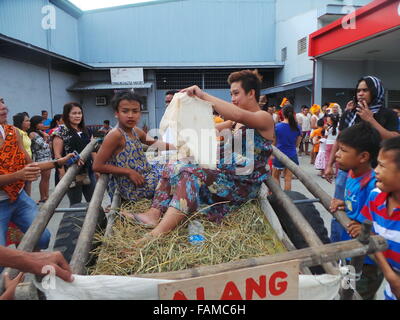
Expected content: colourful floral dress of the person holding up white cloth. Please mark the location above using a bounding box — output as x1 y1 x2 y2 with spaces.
152 127 272 222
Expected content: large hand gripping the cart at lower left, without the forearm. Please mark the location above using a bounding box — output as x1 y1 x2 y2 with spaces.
17 251 73 282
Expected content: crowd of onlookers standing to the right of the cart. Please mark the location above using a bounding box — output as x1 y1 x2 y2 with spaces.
259 76 400 300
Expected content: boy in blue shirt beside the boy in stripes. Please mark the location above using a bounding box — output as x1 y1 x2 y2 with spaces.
330 122 383 300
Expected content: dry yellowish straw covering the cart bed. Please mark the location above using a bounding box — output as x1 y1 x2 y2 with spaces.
89 200 286 276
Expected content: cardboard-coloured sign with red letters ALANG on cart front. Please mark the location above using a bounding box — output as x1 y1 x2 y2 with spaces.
158 260 299 300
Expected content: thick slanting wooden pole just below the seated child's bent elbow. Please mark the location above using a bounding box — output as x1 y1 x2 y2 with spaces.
70 174 109 274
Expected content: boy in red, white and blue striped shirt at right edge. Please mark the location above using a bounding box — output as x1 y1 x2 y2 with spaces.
361 137 400 300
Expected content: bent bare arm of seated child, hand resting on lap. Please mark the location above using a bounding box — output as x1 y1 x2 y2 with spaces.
93 130 144 186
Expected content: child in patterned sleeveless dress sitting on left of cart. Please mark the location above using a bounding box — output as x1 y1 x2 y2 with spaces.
93 91 174 205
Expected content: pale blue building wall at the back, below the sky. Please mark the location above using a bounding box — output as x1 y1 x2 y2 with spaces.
79 0 275 63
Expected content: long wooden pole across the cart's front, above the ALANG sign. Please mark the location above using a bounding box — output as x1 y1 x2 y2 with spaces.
134 236 388 280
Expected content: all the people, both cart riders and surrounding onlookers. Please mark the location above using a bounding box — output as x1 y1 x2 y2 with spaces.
0 70 400 299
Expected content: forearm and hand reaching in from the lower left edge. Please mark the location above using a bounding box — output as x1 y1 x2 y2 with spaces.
0 246 73 282
